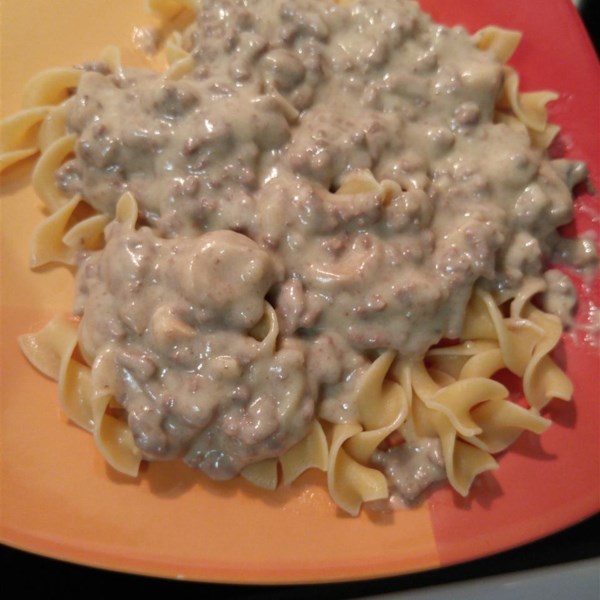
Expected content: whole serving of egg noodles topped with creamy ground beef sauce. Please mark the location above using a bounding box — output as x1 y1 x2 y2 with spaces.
0 0 596 515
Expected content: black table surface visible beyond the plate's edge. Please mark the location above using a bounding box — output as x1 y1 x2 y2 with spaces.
0 0 600 600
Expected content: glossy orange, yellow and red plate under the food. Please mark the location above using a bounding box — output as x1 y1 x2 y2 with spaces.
0 0 600 584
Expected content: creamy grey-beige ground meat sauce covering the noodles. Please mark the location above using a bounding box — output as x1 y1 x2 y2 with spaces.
57 0 587 486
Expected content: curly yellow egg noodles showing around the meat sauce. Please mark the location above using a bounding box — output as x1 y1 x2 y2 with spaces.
0 0 573 515
